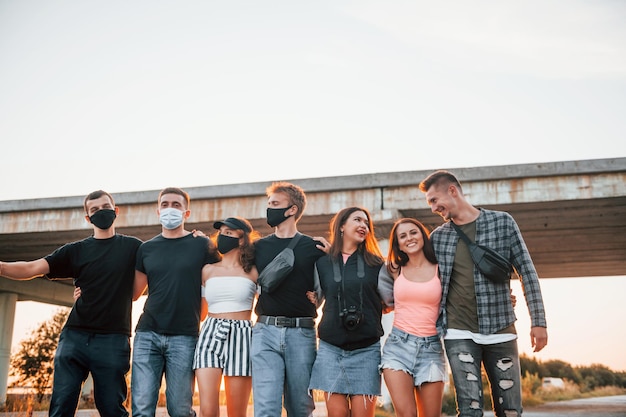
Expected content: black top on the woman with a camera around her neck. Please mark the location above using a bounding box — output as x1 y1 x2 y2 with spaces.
316 252 385 350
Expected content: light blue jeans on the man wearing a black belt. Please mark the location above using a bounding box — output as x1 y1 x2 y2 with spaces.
251 322 317 417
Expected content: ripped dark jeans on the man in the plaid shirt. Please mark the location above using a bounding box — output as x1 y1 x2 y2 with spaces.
444 339 522 417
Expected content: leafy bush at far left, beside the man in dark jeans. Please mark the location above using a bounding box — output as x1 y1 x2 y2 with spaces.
10 308 70 402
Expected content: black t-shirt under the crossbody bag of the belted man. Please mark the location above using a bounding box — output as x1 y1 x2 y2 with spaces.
254 234 324 317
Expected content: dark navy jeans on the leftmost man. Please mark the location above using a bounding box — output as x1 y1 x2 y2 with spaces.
49 329 130 417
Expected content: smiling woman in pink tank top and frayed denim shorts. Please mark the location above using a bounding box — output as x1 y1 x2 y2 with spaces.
381 218 448 417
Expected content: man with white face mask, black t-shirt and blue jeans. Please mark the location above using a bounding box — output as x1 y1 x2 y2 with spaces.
131 187 219 417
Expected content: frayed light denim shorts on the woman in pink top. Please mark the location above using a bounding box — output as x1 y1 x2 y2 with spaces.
380 327 448 387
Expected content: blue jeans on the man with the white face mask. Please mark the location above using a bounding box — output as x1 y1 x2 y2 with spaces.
131 331 198 417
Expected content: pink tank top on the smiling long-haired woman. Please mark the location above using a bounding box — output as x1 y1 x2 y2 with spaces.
393 264 441 337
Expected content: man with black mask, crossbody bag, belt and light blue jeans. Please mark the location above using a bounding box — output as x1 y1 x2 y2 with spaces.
251 182 330 417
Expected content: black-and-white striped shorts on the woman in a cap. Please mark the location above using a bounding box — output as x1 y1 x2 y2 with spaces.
193 317 252 376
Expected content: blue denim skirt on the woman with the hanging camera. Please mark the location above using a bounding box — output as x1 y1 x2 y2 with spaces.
309 340 381 396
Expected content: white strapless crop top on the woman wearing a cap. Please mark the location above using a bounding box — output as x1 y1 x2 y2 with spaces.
202 276 256 313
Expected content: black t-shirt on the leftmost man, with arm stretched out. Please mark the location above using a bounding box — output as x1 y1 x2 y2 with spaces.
45 234 141 336
